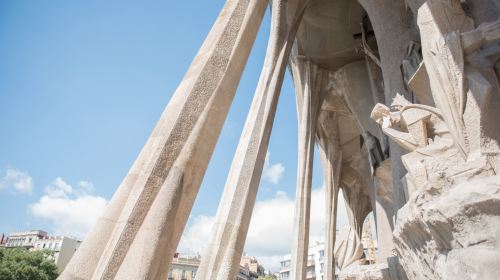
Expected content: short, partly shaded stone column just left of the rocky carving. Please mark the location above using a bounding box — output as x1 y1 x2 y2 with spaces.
374 159 394 262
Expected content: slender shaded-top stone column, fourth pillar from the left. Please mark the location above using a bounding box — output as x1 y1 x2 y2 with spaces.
317 111 342 279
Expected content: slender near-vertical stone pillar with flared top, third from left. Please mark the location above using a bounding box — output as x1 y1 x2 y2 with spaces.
290 57 328 279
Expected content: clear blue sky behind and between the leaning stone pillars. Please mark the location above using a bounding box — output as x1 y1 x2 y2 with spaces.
0 0 344 270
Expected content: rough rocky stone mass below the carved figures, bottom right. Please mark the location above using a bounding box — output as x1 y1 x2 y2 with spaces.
394 176 500 279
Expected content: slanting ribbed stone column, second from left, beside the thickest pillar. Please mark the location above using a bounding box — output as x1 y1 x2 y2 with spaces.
192 0 305 280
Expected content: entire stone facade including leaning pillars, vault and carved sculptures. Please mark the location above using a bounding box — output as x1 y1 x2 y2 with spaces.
60 0 500 280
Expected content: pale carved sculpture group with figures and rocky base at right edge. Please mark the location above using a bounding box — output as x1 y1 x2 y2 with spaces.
372 0 500 279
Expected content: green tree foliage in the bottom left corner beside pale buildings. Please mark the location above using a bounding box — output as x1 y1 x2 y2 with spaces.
0 248 58 280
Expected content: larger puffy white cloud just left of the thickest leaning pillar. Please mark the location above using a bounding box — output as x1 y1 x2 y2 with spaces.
28 177 107 238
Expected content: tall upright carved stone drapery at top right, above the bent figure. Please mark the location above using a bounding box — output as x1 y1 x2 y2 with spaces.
418 0 500 172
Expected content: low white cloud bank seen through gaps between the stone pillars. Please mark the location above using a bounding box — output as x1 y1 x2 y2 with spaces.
179 188 348 271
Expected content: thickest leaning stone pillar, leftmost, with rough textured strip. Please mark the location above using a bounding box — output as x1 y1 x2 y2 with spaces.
60 0 266 279
